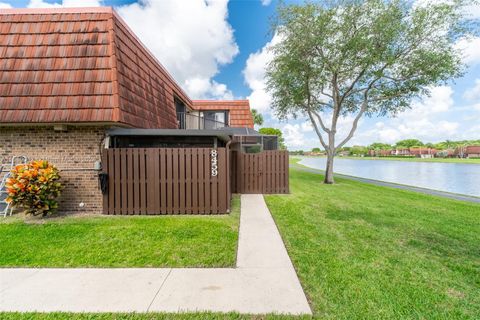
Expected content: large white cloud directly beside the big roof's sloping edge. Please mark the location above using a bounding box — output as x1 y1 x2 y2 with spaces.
117 0 238 98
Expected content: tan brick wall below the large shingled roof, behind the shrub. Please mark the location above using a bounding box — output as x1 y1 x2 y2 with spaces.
0 127 105 213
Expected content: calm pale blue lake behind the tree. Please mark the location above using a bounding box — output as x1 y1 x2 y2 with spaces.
299 157 480 197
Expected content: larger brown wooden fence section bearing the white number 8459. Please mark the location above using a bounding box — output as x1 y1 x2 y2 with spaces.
102 148 231 215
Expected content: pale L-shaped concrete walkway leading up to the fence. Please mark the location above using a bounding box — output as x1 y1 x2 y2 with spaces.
0 195 311 314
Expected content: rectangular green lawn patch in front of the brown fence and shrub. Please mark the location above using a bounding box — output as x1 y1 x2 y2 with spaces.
0 197 240 267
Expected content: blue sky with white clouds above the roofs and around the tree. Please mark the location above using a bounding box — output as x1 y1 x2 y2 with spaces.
0 0 480 150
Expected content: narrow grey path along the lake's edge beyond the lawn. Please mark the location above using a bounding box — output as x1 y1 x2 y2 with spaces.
290 164 480 203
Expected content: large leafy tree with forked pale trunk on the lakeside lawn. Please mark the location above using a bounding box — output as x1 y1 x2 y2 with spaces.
266 0 468 183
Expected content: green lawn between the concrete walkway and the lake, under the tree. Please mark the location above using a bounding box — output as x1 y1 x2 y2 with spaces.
266 169 480 319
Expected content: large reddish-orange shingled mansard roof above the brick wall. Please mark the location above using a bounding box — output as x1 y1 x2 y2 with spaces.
0 7 191 128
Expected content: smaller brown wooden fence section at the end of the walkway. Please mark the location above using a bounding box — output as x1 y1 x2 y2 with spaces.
231 150 289 193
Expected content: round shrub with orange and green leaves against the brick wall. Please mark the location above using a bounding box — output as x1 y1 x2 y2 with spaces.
6 160 62 216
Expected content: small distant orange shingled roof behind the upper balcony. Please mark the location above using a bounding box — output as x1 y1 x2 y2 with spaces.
192 100 254 128
